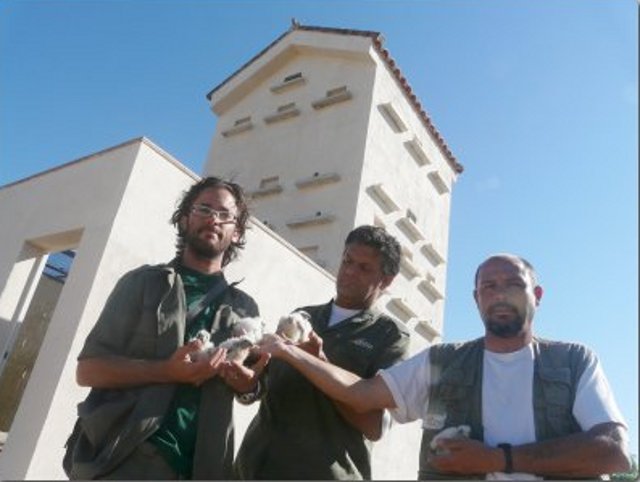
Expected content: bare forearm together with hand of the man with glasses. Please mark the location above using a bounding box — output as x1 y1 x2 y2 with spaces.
76 341 226 388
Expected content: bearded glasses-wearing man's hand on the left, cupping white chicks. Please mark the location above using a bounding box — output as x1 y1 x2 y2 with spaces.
165 340 227 386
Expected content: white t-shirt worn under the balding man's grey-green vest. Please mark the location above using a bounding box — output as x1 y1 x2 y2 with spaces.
379 344 626 479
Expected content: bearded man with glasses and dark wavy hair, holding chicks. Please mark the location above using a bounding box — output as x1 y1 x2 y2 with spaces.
65 177 267 480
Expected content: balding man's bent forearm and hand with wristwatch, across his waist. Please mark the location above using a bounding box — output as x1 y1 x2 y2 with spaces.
430 423 629 478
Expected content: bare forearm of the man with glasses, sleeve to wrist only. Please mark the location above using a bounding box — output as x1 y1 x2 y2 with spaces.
76 358 175 388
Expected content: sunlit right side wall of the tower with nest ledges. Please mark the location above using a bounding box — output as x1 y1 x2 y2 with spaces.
357 44 456 339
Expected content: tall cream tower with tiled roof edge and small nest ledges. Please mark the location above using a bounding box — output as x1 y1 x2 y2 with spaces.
204 22 462 342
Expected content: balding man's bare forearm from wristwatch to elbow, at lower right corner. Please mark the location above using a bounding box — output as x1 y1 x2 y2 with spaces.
513 423 629 477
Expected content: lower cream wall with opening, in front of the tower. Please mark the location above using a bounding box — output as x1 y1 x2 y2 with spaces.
0 140 432 480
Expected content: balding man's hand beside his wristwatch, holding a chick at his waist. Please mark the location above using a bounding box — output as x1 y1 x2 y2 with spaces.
429 438 504 475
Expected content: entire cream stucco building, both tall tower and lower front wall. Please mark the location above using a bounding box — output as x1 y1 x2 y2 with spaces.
0 21 462 480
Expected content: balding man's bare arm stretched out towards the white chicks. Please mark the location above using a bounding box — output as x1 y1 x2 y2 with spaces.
259 339 395 414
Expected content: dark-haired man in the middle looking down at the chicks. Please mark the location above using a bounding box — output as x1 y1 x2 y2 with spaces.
234 226 409 480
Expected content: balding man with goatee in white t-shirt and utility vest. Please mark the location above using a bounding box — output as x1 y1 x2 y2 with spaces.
263 254 629 480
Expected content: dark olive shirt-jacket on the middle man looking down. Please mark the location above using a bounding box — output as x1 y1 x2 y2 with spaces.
234 303 409 480
